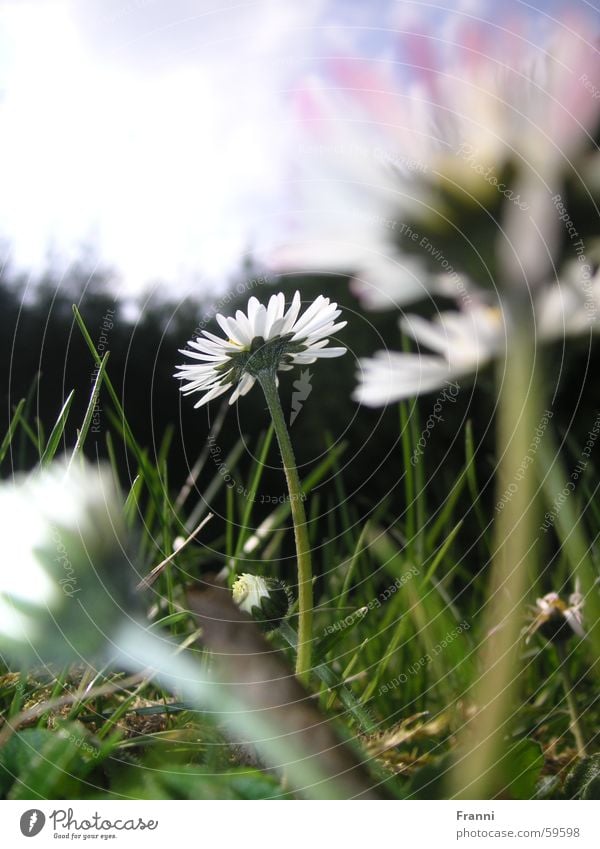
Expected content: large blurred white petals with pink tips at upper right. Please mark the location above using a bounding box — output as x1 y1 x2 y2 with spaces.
275 21 600 308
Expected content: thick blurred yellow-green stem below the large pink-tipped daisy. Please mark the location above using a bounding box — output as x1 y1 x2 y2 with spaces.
451 322 540 799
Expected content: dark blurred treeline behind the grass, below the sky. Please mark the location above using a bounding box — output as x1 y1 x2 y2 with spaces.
0 256 596 576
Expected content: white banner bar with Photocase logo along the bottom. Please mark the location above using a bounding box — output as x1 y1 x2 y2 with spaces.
0 801 600 849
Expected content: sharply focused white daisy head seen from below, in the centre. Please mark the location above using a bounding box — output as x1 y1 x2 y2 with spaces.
175 292 347 407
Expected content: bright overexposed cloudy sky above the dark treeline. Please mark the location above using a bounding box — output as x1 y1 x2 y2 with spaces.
0 0 592 294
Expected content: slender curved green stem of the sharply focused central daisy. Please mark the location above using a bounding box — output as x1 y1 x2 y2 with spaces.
257 370 313 683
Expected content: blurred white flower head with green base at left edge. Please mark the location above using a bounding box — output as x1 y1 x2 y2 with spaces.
0 461 134 662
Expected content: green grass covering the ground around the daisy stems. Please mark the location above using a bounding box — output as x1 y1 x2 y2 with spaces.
0 312 600 799
